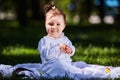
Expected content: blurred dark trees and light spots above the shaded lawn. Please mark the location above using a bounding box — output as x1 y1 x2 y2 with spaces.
0 0 120 26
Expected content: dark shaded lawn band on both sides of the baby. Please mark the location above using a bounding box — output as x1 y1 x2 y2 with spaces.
0 25 120 47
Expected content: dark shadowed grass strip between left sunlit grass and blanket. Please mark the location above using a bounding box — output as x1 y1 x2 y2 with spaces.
0 55 41 65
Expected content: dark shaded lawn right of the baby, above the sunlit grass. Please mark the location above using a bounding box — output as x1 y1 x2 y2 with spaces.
65 25 120 48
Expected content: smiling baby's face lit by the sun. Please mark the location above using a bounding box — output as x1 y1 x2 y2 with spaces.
45 15 65 38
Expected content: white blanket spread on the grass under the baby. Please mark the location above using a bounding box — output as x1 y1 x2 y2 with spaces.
0 62 120 80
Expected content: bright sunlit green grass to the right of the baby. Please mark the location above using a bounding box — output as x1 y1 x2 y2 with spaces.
73 45 120 66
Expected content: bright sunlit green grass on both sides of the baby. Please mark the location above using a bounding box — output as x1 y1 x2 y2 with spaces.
2 45 120 66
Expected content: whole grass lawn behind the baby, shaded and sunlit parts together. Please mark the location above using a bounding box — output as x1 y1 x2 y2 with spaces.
0 20 120 79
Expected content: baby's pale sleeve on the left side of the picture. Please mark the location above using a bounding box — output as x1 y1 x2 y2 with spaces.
38 38 60 61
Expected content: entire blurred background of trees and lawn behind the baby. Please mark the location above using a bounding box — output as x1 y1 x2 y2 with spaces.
0 0 120 66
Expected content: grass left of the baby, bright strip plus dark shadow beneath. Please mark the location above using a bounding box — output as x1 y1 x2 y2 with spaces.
0 45 41 65
